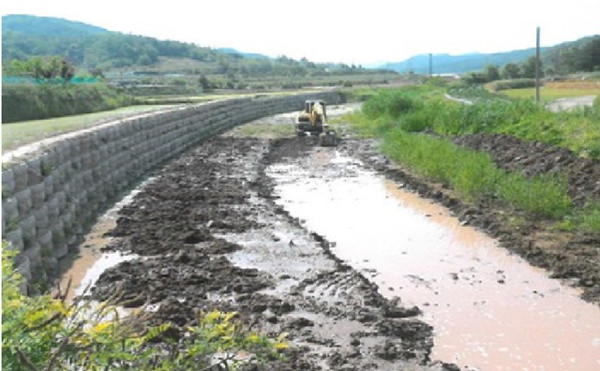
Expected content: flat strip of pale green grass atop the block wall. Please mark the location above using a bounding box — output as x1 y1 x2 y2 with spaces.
2 105 172 152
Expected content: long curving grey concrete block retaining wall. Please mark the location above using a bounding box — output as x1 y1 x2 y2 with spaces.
2 92 342 293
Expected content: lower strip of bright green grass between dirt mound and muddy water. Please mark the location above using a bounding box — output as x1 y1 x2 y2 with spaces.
382 129 571 220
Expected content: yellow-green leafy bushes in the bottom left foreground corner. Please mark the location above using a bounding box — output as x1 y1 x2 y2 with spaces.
2 242 288 371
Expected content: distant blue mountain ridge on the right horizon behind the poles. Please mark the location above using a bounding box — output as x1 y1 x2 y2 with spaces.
379 47 550 74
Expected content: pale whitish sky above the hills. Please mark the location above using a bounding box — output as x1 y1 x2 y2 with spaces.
0 0 600 66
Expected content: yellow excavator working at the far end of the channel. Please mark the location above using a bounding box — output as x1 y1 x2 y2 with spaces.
296 100 337 147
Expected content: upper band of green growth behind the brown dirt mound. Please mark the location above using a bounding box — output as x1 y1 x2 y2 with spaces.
363 87 600 158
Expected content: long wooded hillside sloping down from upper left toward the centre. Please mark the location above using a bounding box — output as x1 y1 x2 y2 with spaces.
2 15 395 76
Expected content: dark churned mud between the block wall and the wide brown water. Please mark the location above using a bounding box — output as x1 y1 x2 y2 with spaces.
93 138 456 370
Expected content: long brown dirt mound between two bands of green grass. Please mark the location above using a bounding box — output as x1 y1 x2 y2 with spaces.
455 134 600 206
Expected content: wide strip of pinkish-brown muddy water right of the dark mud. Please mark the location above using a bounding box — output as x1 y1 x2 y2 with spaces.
268 149 600 370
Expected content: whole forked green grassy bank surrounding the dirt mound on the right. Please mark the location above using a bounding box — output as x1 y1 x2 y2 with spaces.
347 86 600 232
